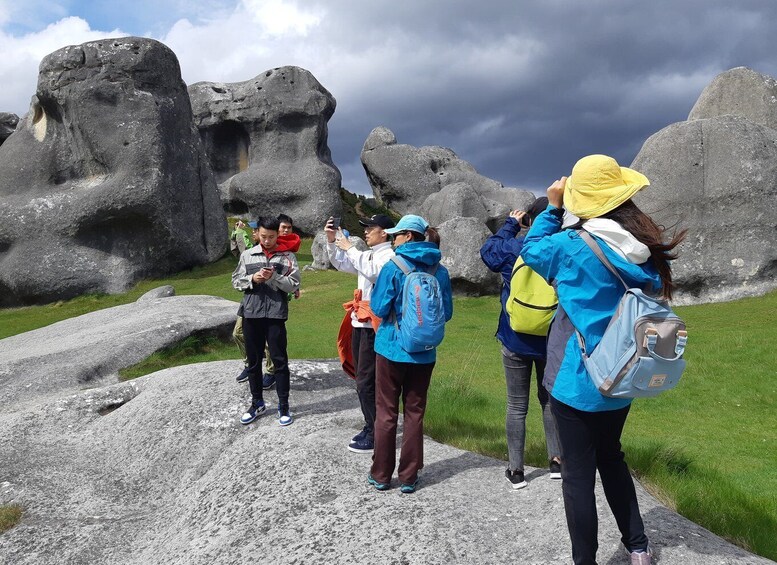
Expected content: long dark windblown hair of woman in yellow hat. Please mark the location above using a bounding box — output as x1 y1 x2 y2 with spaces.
600 200 688 300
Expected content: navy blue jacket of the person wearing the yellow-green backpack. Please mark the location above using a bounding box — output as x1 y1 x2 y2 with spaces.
480 218 546 359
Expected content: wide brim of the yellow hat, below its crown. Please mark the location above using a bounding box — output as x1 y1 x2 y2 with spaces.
564 167 650 220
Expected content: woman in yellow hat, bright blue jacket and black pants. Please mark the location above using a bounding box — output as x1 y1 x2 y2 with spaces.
522 155 685 565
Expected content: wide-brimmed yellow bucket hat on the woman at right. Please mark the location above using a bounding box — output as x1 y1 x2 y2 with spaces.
564 155 650 219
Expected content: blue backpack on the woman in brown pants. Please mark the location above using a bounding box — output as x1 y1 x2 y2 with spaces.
391 255 445 353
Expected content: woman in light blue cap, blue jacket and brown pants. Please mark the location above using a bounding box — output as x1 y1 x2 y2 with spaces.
367 215 453 493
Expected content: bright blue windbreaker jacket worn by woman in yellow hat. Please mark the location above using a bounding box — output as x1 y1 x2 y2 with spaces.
521 206 661 412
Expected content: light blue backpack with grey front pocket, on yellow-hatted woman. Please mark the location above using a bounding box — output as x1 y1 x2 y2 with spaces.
575 230 688 398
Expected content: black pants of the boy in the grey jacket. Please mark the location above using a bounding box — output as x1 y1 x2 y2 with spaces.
243 318 289 408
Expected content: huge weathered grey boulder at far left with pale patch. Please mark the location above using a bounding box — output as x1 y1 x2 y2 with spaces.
0 37 227 306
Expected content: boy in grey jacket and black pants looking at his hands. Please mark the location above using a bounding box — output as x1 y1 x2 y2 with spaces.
232 218 300 426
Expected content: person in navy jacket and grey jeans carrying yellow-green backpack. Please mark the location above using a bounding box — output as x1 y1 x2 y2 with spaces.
480 197 561 489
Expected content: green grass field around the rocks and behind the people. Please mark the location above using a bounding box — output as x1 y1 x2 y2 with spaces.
0 240 777 559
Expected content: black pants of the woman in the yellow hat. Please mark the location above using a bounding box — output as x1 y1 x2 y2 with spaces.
550 396 648 565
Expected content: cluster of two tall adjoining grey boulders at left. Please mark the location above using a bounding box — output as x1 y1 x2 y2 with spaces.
0 37 341 306
